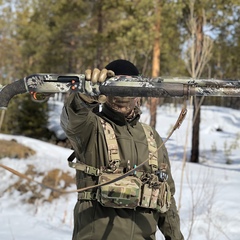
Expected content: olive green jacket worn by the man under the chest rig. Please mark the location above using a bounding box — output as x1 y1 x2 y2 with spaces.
61 93 183 240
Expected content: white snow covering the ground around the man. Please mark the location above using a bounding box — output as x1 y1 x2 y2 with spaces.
0 101 240 240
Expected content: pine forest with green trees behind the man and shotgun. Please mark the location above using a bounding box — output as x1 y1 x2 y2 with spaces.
0 0 240 161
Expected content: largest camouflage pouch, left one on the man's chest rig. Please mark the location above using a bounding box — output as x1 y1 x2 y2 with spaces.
97 173 142 209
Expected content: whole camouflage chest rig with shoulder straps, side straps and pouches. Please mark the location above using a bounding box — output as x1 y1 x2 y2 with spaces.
68 118 171 212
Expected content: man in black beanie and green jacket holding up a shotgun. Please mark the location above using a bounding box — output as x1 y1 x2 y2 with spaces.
61 59 183 240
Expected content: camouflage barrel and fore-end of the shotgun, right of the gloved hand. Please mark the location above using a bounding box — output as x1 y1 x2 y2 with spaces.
99 76 240 97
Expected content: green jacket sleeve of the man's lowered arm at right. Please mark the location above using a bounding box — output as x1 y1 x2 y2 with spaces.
155 132 184 240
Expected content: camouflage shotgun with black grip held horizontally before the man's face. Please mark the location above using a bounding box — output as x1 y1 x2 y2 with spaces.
0 73 240 109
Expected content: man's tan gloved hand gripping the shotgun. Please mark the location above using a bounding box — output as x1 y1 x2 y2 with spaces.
80 68 115 103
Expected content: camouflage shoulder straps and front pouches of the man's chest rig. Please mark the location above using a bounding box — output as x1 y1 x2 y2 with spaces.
95 118 171 213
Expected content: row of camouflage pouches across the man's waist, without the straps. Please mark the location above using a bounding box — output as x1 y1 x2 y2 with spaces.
97 173 171 213
